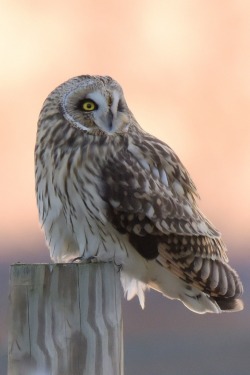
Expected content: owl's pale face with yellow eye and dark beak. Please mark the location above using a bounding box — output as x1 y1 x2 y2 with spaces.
55 76 131 134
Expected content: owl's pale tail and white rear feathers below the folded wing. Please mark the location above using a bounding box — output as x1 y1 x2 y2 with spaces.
121 260 244 314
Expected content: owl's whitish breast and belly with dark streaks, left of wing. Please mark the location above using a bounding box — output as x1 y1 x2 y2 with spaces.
37 142 129 262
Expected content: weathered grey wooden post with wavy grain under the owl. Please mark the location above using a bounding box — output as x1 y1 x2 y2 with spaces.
8 263 123 375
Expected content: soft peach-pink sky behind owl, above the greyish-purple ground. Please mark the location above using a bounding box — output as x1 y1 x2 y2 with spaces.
0 0 250 259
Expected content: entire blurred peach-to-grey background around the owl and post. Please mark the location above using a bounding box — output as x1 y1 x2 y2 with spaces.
0 0 250 375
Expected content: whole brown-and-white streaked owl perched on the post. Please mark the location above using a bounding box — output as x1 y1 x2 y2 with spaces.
35 75 243 314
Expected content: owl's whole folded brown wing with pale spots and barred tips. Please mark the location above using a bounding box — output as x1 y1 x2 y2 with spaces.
99 135 242 297
